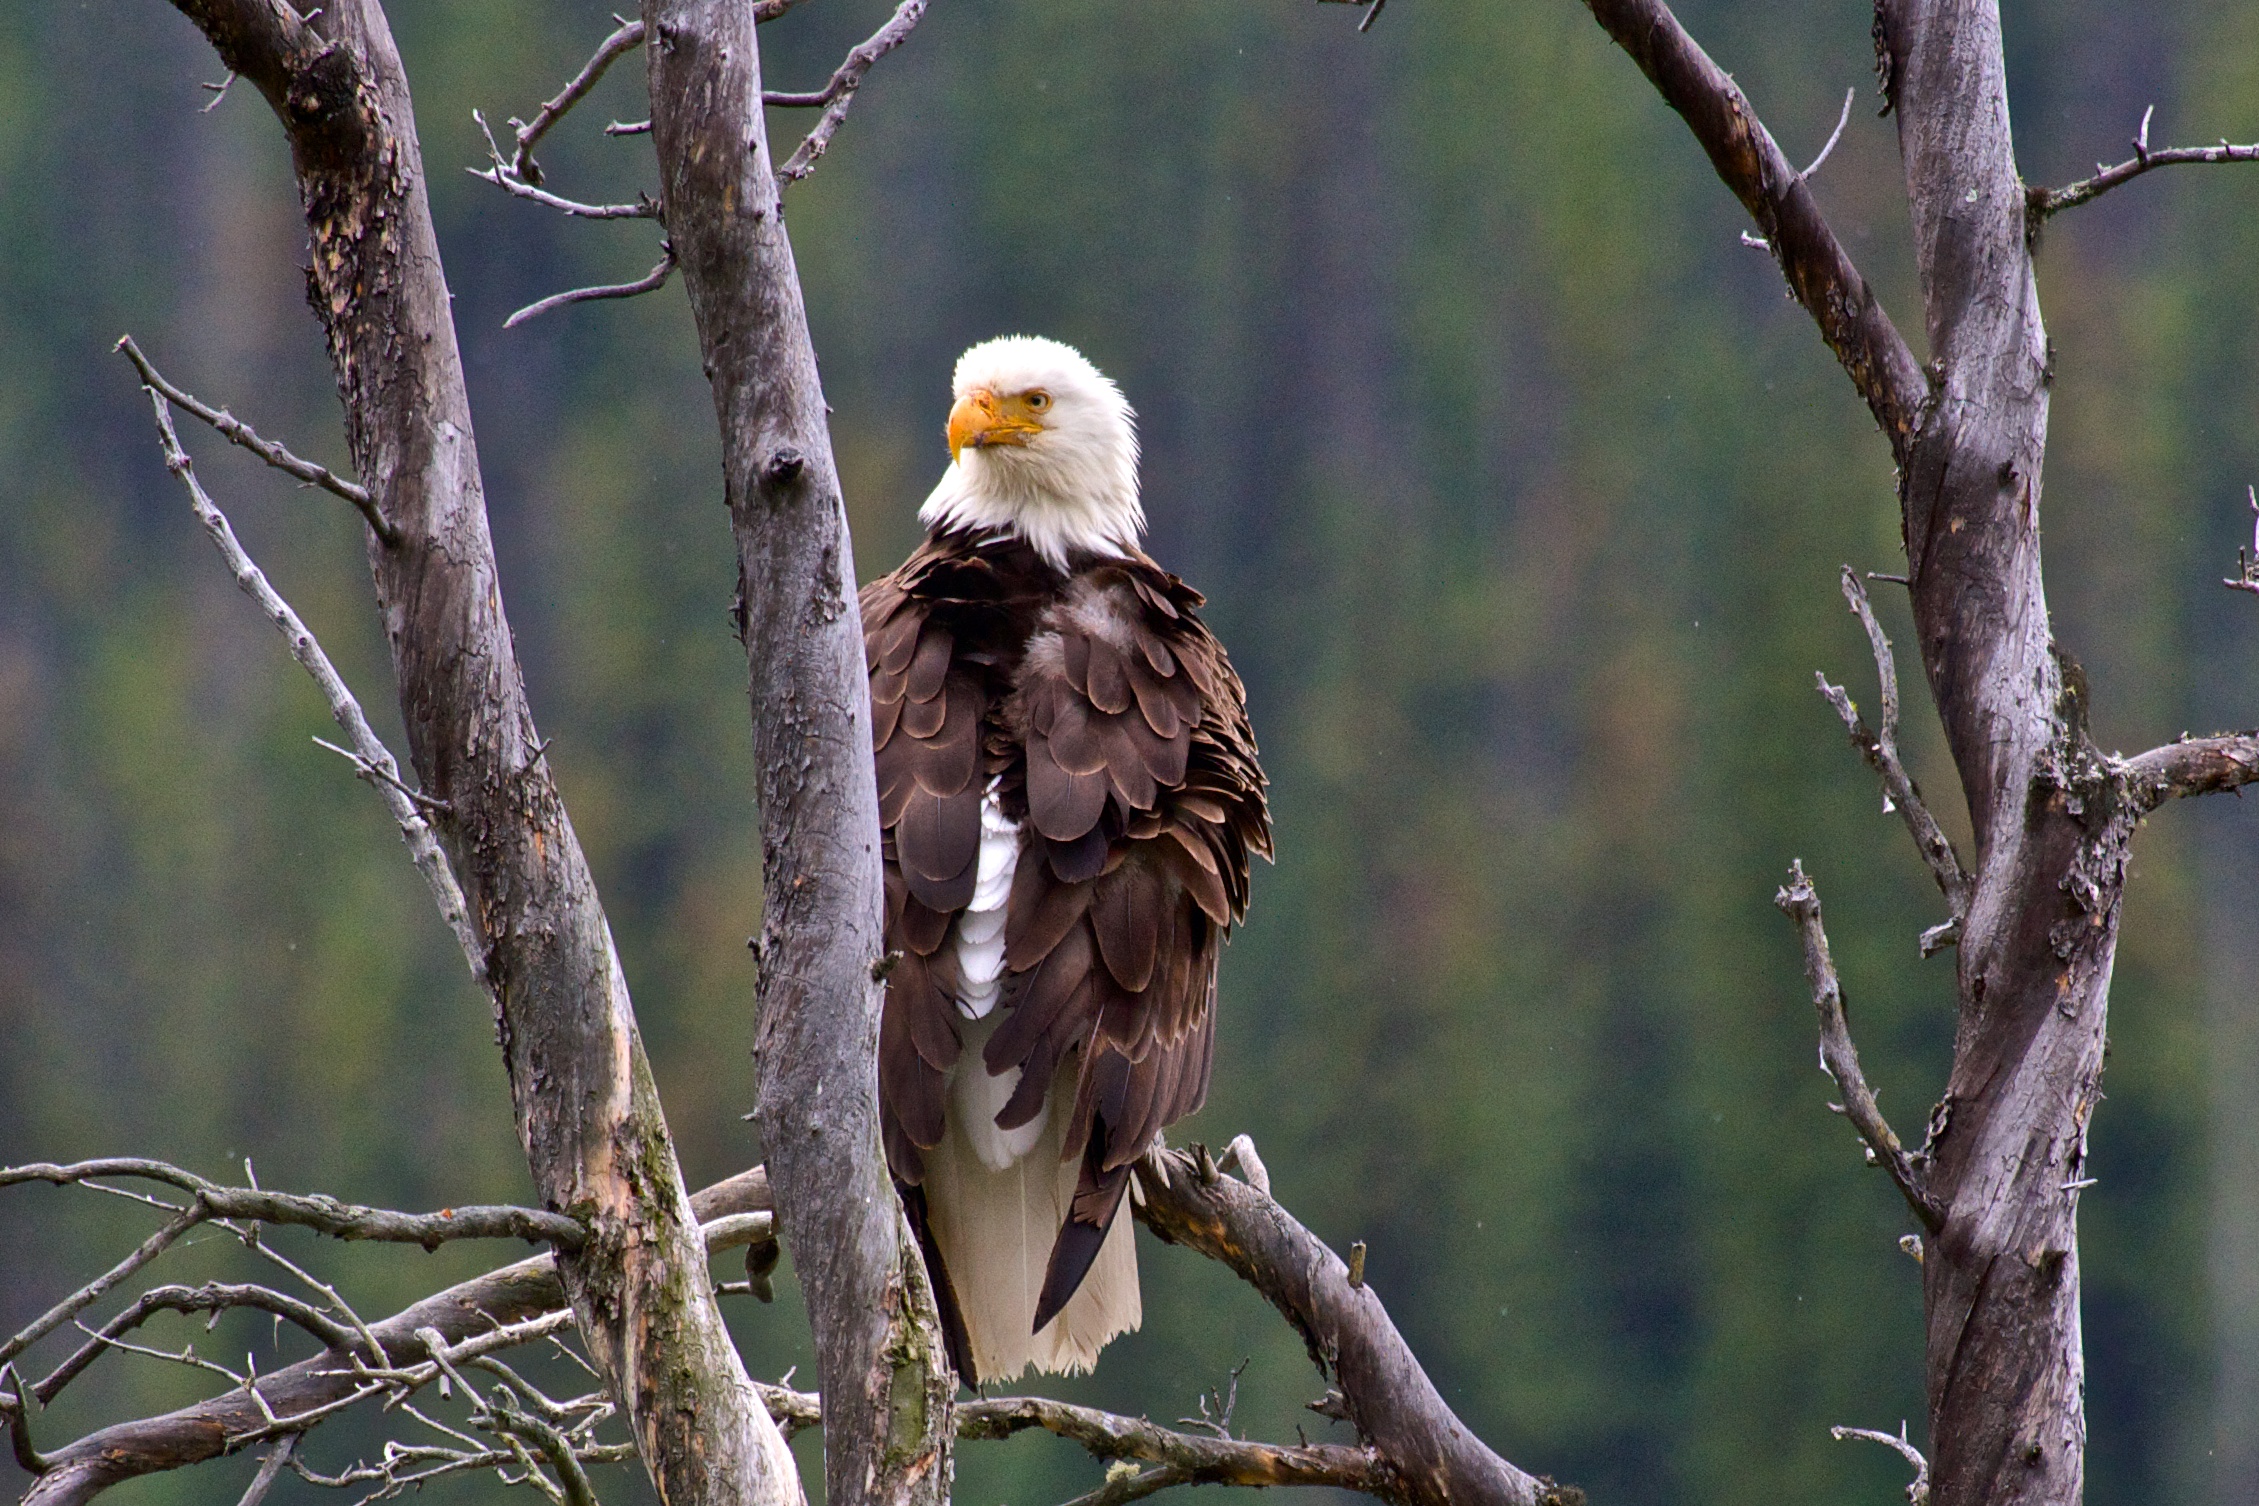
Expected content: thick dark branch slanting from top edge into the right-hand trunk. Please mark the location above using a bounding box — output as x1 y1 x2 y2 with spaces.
1586 0 1929 454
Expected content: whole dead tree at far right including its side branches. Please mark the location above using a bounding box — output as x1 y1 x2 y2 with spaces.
1588 0 2254 1506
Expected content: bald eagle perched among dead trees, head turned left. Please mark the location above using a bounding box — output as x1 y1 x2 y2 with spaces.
861 336 1272 1384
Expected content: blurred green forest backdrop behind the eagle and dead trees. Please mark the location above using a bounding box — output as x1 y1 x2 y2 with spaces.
0 0 2259 1506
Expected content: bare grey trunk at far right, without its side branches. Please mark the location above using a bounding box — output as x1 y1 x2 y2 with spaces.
1879 0 2096 1506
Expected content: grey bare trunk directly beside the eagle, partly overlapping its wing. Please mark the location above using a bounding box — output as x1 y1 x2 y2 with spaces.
644 0 956 1506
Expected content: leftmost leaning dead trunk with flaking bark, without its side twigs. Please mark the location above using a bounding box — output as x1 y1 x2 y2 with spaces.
147 0 800 1504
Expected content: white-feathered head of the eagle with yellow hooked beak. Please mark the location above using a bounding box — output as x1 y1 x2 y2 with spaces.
917 334 1145 569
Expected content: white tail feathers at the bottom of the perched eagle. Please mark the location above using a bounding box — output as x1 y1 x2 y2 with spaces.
924 1018 1145 1382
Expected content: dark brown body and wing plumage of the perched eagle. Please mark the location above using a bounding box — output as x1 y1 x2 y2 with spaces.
863 531 1270 1375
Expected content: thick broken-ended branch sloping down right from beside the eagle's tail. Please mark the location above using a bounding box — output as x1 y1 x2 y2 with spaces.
1136 1149 1584 1506
